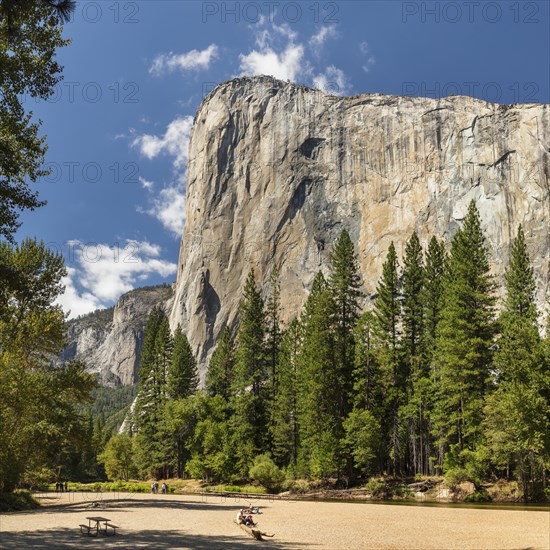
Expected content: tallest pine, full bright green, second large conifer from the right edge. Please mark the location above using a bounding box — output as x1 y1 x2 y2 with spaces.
433 201 495 468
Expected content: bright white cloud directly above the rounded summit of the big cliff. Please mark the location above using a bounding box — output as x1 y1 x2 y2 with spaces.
239 44 304 81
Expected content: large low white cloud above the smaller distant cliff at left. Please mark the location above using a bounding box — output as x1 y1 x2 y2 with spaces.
57 240 177 317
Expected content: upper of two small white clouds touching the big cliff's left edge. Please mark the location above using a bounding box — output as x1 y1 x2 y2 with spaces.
132 116 193 168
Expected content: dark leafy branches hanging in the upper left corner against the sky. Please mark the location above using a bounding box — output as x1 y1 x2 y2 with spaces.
0 0 70 242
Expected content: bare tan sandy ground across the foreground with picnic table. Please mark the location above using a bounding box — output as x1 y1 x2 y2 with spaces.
0 493 550 550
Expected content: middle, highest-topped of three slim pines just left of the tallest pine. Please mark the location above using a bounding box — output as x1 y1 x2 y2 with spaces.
402 233 429 474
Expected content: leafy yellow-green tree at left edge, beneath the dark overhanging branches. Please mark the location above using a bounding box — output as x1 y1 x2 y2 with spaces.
0 239 95 491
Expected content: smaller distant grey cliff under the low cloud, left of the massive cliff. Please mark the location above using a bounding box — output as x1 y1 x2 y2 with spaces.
61 285 172 386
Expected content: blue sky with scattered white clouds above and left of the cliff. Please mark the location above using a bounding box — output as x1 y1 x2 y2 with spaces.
18 0 550 316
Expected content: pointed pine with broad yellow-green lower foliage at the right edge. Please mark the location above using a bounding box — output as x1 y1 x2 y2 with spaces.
485 226 550 500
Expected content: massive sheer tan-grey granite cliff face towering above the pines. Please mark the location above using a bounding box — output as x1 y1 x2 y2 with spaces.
171 77 550 376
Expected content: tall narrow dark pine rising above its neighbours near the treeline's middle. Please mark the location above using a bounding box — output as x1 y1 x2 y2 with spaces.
329 229 361 419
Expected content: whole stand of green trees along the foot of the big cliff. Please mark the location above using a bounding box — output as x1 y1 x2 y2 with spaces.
118 221 550 499
